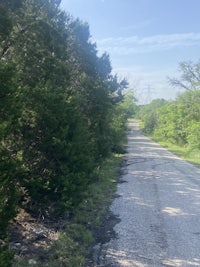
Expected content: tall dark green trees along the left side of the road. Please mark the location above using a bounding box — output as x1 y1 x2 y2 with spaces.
0 0 135 266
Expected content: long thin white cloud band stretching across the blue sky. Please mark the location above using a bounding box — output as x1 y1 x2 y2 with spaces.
97 33 200 55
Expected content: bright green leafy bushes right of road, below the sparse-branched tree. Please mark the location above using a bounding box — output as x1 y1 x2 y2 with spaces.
154 90 200 149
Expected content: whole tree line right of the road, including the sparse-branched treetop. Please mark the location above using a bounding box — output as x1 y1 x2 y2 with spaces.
140 62 200 150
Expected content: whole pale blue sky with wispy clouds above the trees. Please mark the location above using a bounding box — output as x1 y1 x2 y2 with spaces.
61 0 200 102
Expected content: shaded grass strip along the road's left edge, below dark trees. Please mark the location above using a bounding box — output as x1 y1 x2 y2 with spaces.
13 154 123 267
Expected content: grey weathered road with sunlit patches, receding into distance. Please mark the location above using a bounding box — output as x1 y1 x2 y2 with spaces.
95 120 200 267
